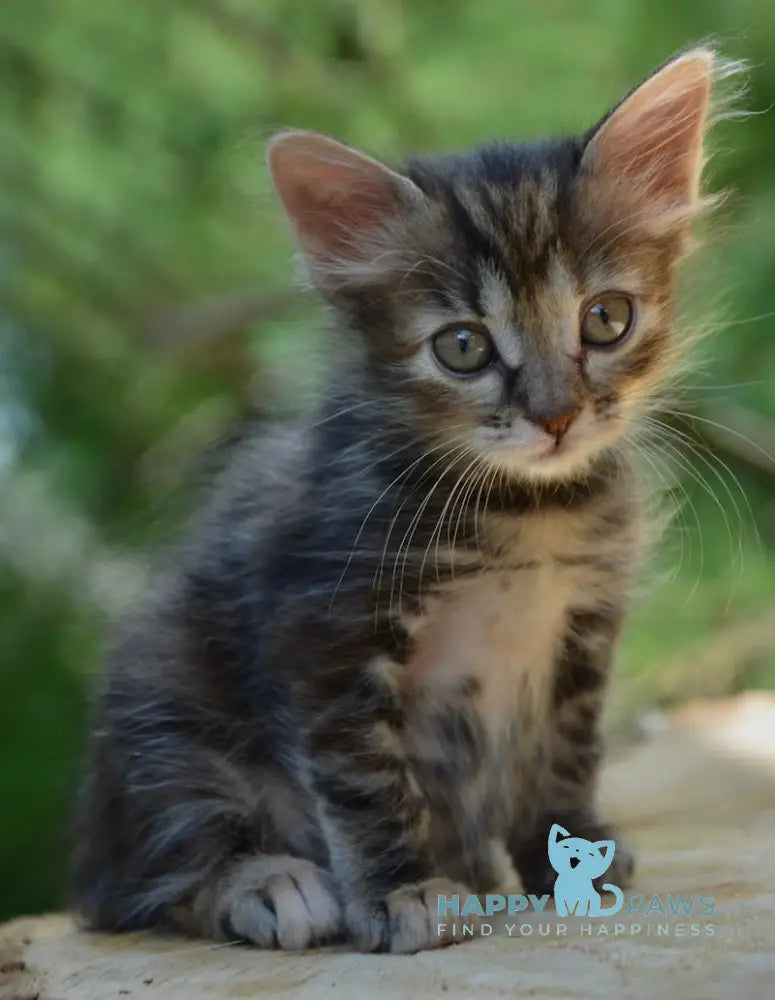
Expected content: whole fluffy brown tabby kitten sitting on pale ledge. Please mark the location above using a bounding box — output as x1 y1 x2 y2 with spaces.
75 47 719 952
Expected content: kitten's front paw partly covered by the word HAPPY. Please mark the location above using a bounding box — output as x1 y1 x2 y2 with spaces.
346 878 478 954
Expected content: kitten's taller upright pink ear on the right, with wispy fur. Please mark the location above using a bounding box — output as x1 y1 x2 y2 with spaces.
582 47 715 209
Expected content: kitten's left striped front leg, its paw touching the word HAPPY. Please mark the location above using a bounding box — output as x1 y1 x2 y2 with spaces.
304 658 469 952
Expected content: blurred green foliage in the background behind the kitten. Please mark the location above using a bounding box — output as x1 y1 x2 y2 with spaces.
0 0 775 918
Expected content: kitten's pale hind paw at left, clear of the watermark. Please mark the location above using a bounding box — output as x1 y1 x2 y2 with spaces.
216 854 342 950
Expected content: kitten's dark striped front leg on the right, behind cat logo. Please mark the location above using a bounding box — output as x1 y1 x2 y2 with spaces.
509 607 635 894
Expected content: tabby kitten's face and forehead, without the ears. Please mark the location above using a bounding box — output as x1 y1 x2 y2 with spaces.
374 152 676 480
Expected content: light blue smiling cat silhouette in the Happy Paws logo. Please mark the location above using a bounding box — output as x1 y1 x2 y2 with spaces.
549 823 624 917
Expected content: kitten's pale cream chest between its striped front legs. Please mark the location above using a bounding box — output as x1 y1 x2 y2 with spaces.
406 516 610 758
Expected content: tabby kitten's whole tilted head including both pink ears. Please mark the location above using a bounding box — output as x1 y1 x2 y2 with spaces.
268 48 732 481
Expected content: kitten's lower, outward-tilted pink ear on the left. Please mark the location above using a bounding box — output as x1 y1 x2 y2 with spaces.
267 132 423 276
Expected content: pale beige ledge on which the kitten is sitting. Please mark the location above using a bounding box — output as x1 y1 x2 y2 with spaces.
0 693 775 1000
